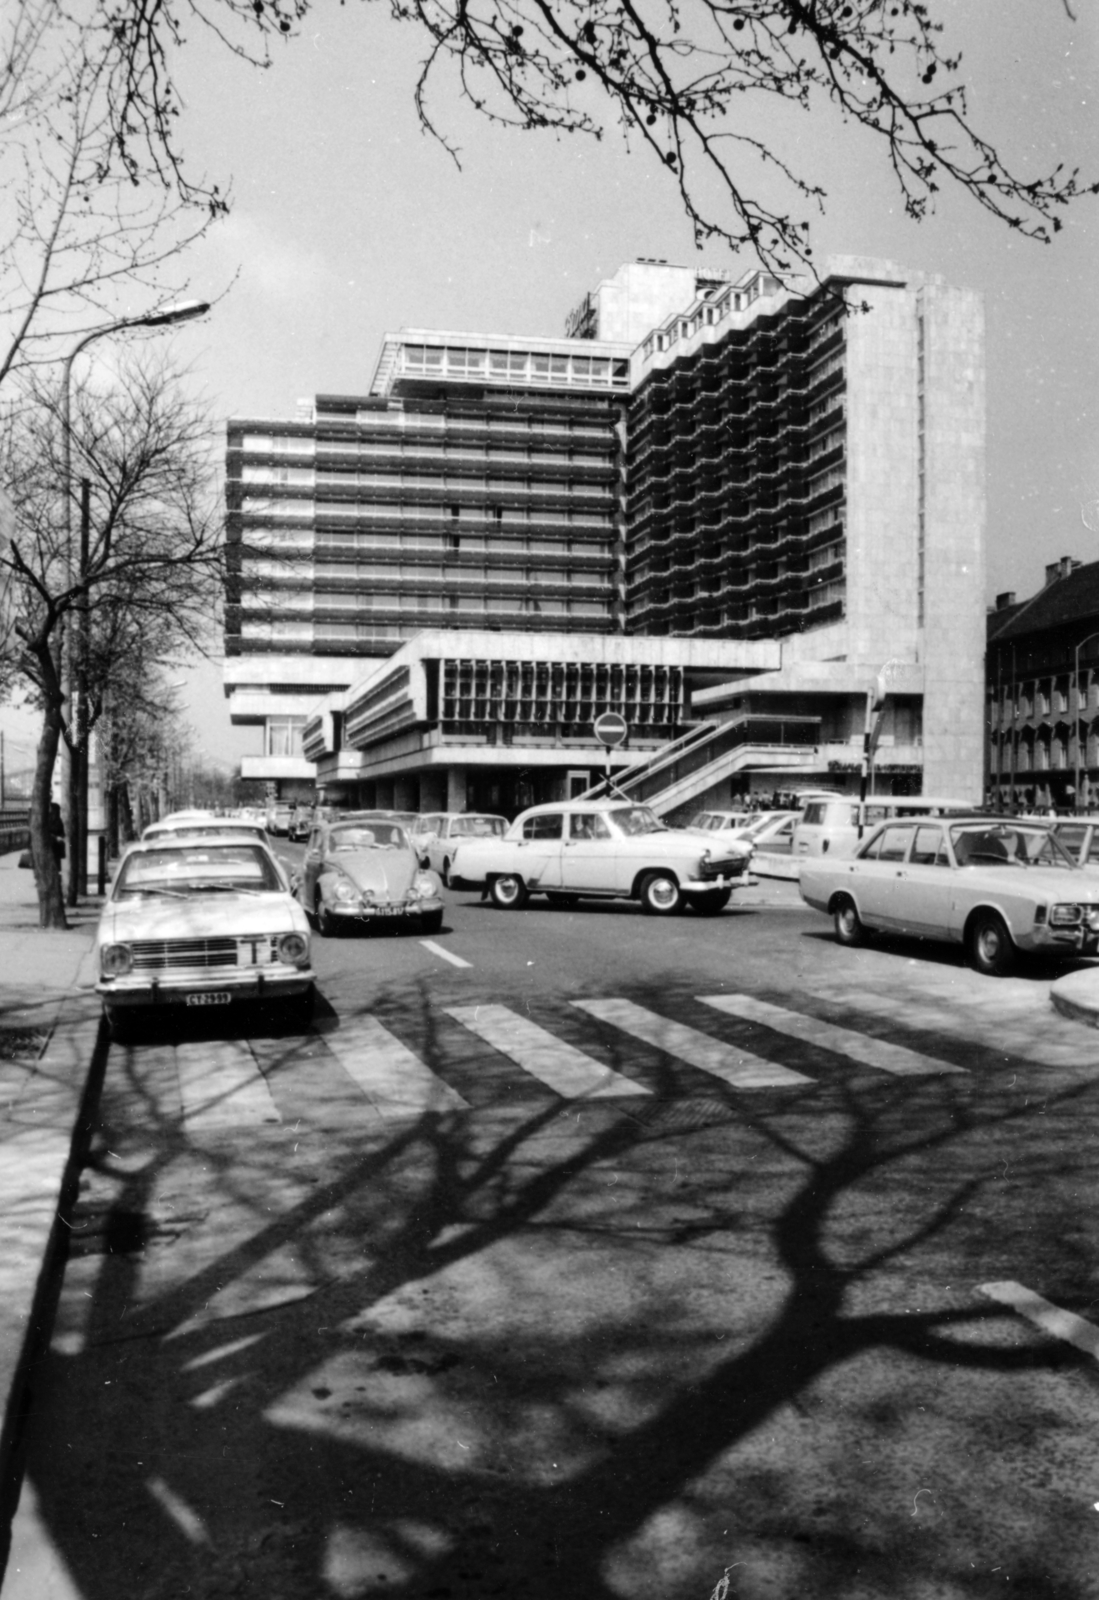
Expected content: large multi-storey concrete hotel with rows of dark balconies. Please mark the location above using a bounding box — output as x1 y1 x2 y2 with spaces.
226 261 984 805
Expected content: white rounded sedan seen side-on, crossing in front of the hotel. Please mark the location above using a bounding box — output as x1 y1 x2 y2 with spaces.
451 800 752 917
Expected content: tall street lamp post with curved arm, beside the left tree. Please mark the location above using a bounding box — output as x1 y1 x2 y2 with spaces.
61 299 210 906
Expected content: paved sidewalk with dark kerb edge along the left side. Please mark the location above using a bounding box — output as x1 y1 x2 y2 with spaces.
0 853 102 1578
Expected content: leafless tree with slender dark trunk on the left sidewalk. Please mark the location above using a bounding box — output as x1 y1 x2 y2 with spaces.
0 350 222 926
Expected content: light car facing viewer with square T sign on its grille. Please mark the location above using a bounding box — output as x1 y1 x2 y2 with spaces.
96 834 314 1032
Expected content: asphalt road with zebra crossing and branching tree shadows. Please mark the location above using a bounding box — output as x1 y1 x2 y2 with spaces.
3 888 1099 1600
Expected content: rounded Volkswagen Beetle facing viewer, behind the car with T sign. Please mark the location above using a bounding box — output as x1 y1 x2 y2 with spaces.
298 816 443 936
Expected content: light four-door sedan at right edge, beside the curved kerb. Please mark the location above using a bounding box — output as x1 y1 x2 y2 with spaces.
800 816 1099 974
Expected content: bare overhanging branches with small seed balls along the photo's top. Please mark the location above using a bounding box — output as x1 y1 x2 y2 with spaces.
29 0 1097 284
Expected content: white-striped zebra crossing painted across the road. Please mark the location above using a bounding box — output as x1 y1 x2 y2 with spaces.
109 994 998 1131
